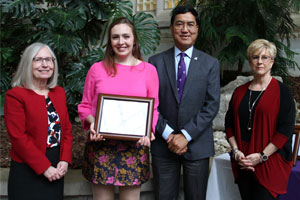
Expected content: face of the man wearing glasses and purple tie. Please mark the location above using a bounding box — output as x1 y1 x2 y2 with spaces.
170 12 198 51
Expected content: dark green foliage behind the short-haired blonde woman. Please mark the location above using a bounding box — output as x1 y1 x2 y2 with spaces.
182 0 300 76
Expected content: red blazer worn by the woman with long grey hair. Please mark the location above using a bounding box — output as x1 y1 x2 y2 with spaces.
4 86 73 174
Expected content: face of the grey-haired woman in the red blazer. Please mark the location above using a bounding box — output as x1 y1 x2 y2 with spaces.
32 47 54 84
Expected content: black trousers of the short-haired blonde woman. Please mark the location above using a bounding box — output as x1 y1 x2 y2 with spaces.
237 170 277 200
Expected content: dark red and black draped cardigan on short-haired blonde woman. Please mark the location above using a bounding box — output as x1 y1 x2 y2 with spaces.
225 79 295 197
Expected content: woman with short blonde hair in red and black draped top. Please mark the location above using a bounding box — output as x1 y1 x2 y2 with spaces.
225 39 295 200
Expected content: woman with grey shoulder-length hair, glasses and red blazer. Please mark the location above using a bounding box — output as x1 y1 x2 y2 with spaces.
4 43 73 200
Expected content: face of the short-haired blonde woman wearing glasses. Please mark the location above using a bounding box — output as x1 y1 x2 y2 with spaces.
250 49 274 76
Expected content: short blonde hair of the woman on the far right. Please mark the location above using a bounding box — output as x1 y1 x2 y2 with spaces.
247 39 277 60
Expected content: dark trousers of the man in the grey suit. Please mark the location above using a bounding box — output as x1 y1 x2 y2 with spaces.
152 155 209 200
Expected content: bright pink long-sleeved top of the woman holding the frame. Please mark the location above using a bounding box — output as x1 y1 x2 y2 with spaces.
78 61 159 133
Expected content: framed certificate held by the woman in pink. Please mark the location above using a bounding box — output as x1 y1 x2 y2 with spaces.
95 94 154 140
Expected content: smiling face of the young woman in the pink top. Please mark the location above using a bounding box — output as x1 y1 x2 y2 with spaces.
110 24 134 58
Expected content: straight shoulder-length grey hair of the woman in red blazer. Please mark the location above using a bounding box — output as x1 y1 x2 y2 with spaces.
11 42 58 89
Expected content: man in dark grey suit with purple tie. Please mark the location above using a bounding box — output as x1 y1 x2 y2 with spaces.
149 6 220 200
